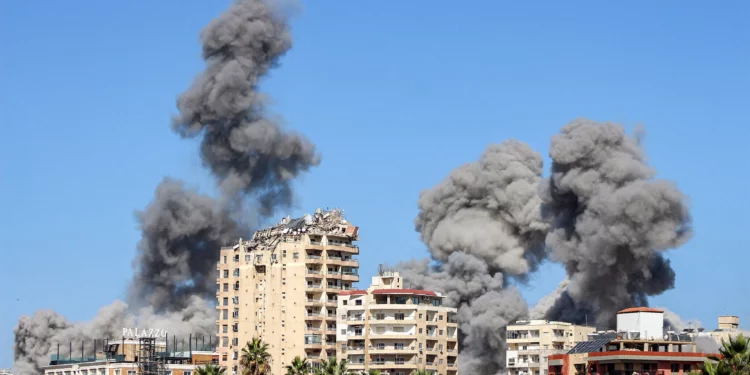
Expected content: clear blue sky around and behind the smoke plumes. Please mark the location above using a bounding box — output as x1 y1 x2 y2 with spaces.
0 0 750 368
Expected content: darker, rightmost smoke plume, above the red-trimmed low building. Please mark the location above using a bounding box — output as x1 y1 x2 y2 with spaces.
540 119 692 329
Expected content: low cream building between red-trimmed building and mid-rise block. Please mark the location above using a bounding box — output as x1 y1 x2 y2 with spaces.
505 320 596 375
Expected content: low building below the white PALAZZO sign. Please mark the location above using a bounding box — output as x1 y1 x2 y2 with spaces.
44 338 219 375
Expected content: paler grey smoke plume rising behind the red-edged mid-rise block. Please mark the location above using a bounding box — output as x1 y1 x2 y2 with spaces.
397 141 547 374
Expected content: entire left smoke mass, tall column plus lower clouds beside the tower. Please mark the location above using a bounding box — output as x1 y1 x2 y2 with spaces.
14 0 320 375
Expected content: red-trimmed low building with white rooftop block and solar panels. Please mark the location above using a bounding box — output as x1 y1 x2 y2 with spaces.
548 308 711 375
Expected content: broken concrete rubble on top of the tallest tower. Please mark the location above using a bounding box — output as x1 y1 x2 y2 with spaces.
244 208 359 251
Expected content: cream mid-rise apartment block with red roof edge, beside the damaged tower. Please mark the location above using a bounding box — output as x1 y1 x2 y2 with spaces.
336 270 458 375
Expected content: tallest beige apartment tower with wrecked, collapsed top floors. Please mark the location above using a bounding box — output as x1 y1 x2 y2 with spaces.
216 209 359 375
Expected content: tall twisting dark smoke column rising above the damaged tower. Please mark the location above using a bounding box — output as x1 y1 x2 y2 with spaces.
172 0 320 204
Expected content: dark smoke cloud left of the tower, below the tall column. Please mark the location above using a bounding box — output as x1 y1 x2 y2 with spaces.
130 178 246 311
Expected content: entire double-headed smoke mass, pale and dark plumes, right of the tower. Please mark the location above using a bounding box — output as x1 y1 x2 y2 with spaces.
397 120 691 375
